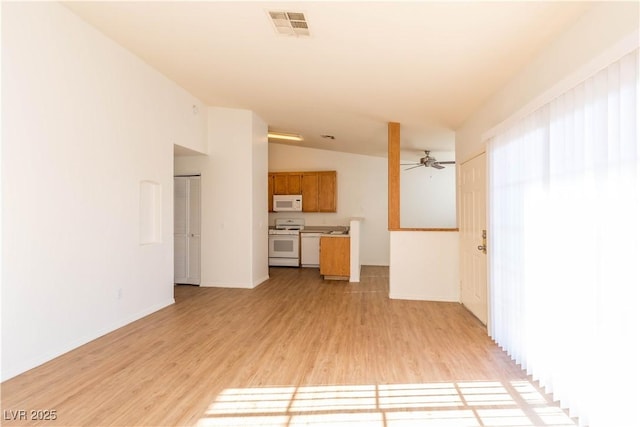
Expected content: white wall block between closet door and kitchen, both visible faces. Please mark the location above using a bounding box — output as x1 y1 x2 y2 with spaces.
174 107 269 288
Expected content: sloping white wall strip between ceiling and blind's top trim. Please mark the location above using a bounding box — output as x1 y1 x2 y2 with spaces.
456 2 640 164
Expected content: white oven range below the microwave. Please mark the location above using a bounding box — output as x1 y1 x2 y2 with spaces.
269 218 304 267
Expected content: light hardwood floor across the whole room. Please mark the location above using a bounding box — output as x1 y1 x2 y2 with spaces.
2 267 574 427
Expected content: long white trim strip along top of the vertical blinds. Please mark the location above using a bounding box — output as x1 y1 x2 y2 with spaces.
482 30 640 142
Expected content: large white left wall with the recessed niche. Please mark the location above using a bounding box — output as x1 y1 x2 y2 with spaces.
2 2 205 380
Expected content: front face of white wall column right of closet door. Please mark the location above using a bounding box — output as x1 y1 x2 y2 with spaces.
206 107 253 288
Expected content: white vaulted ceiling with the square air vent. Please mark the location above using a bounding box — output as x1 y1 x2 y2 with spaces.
65 1 592 160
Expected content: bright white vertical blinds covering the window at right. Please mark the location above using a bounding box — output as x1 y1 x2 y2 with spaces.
488 50 640 427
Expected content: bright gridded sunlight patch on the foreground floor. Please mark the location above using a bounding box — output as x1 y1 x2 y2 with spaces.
197 380 575 427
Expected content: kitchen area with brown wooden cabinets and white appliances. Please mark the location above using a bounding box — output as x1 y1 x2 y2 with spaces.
268 171 362 282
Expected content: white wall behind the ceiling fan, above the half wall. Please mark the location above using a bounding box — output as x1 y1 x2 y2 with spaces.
400 151 456 228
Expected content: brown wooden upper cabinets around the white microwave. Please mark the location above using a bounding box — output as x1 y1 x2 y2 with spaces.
268 171 337 212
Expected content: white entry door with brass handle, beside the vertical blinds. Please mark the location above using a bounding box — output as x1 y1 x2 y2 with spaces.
460 153 488 325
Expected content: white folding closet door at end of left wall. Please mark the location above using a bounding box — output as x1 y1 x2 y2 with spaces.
173 176 200 285
